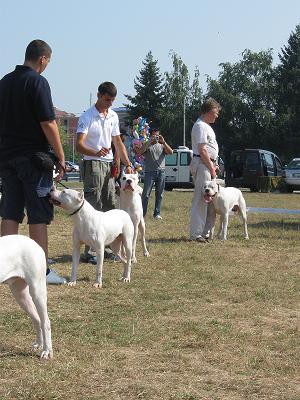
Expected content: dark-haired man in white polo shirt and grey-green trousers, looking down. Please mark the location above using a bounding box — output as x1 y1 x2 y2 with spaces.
76 82 132 264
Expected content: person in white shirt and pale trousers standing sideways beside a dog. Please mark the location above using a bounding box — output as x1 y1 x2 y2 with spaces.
190 98 221 242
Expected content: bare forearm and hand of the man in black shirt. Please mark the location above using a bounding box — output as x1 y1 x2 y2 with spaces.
40 120 65 180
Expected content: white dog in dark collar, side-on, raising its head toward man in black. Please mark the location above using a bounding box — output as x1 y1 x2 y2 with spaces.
50 189 134 288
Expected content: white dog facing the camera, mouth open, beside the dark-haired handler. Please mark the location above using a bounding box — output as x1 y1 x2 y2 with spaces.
120 174 149 263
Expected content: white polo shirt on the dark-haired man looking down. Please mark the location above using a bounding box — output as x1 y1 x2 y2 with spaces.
77 105 120 162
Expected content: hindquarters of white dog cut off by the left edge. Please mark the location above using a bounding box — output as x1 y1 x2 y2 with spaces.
0 235 53 359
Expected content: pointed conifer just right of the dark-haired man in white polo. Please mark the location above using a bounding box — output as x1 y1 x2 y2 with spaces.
124 51 163 125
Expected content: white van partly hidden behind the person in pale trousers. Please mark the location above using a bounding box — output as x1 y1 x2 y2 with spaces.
165 146 224 190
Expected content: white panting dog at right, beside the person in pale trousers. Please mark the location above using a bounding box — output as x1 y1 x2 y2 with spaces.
204 180 249 240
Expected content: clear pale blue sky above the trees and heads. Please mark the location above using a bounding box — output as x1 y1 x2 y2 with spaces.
0 0 300 113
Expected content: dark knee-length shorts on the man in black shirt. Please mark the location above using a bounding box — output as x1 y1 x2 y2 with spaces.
0 156 53 224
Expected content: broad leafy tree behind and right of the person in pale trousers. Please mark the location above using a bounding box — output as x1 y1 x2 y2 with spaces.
207 50 275 158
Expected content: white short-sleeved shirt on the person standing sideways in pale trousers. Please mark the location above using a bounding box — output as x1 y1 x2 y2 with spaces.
191 118 219 160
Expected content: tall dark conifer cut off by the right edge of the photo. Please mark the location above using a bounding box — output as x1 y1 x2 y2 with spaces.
276 25 300 159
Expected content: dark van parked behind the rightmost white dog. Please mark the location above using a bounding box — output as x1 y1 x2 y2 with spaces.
225 149 284 192
